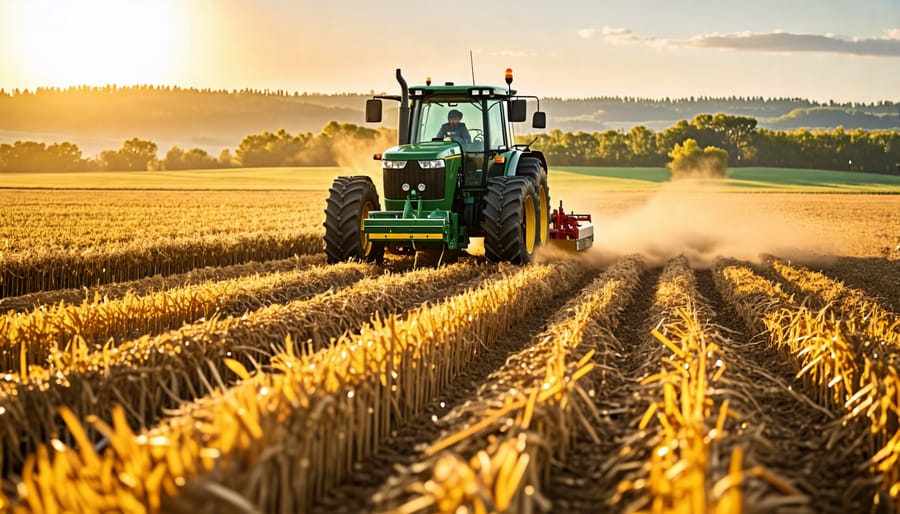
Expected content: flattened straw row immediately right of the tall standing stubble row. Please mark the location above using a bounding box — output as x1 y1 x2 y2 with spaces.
366 255 644 512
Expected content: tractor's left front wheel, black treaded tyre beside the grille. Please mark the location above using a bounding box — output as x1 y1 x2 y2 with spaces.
325 177 384 264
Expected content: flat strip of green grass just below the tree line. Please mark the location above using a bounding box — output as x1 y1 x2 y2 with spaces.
0 166 900 194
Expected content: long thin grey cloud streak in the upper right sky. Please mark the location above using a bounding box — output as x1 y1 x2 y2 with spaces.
577 27 900 57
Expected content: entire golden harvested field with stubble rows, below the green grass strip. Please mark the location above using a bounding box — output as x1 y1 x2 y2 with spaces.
0 191 900 514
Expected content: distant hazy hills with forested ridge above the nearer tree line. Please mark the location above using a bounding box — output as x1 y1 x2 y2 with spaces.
0 84 900 139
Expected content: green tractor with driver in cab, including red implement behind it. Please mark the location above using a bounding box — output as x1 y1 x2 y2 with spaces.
325 69 593 264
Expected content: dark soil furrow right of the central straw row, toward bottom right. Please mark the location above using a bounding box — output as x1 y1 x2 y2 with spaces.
696 270 874 514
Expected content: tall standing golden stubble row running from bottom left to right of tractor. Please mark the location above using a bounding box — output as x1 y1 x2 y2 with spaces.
5 258 584 512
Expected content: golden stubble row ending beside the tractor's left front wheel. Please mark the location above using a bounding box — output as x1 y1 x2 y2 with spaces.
0 256 378 376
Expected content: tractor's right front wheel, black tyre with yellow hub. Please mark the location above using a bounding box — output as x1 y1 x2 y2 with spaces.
482 177 538 264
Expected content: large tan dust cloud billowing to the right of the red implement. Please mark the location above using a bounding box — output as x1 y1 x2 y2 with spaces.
548 181 833 269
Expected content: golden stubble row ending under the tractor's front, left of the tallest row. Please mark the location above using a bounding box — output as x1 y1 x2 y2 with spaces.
0 263 494 480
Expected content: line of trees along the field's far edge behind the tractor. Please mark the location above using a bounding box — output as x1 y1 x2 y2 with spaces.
0 114 900 174
